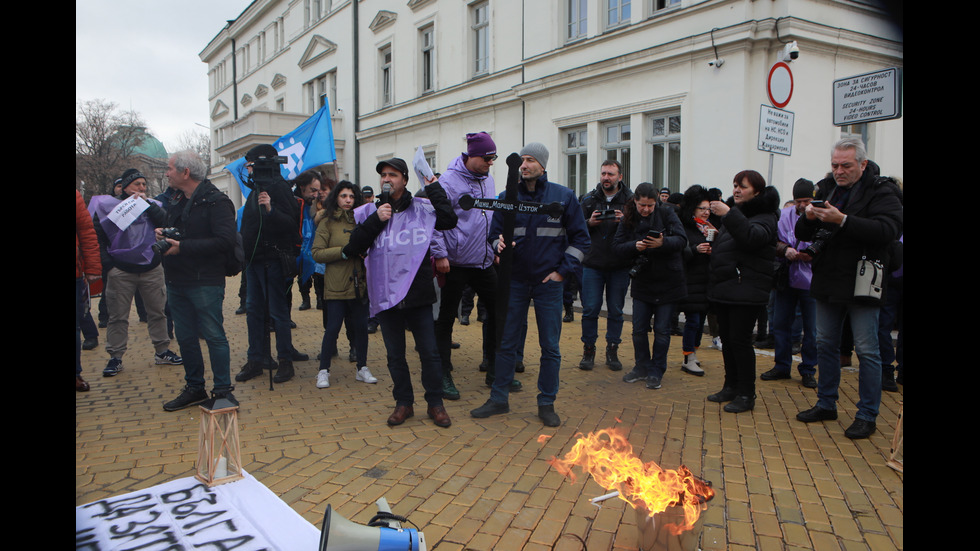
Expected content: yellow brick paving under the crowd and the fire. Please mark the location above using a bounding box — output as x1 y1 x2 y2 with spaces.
75 278 905 551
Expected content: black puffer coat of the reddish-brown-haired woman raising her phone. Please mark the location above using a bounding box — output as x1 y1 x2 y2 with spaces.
708 186 780 306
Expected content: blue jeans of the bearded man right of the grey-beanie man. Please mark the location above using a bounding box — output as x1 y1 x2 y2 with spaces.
582 268 630 346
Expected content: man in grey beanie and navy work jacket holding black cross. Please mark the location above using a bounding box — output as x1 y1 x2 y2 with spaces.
470 142 591 427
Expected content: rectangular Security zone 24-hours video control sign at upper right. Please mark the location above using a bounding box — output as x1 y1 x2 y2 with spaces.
834 68 902 126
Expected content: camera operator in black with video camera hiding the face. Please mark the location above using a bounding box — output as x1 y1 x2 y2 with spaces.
235 145 301 383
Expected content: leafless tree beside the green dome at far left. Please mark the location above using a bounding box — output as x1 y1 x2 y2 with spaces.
75 99 146 200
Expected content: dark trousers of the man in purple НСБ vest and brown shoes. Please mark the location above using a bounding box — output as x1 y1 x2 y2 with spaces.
378 304 442 407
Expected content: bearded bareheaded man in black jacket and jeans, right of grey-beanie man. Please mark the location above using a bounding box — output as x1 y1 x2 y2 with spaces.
578 159 633 371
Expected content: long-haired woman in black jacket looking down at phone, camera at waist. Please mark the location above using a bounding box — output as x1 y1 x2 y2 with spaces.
613 182 687 389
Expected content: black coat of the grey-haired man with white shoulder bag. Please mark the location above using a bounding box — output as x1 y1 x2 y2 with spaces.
796 161 904 305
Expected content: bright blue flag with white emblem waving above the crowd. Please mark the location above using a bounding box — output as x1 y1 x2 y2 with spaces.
225 103 337 198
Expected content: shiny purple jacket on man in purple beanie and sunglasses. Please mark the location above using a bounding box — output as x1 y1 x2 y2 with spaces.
431 155 497 268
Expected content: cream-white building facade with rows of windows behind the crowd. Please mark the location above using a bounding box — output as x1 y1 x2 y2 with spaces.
200 0 904 207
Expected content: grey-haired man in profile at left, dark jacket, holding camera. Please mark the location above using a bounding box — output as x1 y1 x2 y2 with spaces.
157 151 237 411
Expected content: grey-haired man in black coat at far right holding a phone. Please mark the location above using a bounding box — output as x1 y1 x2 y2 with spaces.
795 138 904 439
